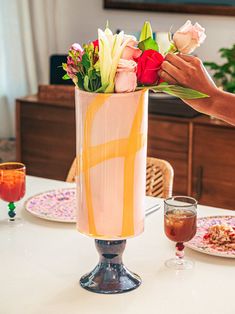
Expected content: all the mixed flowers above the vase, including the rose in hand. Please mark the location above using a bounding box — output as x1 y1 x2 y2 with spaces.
62 21 207 99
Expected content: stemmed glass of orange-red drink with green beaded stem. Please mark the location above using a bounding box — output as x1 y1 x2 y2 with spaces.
0 162 26 222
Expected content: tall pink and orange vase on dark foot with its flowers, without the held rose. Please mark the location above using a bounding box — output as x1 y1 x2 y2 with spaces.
63 22 206 293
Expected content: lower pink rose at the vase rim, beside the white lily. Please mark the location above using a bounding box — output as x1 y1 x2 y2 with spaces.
114 59 137 93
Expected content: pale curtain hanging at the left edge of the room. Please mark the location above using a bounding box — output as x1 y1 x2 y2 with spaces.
0 0 56 138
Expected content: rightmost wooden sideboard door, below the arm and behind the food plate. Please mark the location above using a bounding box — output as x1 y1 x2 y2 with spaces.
193 125 235 209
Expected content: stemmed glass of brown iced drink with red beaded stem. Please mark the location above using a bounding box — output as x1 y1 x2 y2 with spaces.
164 196 197 270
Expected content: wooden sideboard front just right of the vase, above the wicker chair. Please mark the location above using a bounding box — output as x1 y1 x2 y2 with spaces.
148 115 188 195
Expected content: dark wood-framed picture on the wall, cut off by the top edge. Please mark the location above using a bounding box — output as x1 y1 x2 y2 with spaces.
104 0 235 15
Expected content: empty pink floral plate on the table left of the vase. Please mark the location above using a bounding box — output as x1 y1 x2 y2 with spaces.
25 188 76 223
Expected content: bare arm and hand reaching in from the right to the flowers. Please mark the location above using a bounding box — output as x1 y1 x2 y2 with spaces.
160 54 235 125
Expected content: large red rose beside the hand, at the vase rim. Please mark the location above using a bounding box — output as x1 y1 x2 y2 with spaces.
137 49 164 85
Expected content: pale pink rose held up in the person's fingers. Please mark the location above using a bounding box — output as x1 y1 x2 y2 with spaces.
173 20 206 54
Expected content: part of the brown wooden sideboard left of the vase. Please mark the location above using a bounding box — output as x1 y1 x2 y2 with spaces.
16 86 76 180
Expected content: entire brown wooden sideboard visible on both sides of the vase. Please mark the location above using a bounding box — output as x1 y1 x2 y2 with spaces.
16 86 235 209
